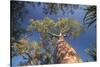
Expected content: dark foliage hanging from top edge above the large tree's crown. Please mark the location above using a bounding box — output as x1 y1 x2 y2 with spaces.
43 3 79 15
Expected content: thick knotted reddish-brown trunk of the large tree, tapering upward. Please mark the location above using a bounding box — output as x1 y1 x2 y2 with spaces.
54 33 81 64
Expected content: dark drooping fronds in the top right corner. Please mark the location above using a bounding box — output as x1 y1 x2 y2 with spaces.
83 6 96 27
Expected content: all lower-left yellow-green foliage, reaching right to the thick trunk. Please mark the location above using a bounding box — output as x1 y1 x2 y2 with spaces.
13 38 54 66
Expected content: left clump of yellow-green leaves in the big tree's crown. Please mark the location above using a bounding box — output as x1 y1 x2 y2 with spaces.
28 17 54 38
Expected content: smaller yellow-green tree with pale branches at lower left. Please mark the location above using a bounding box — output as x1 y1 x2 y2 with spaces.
14 37 41 65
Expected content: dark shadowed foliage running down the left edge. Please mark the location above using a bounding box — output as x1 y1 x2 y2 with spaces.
10 1 26 58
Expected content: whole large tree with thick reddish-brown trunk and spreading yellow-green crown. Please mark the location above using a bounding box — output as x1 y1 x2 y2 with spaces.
28 17 82 64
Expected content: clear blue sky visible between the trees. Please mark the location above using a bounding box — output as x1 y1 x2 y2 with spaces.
12 1 96 65
